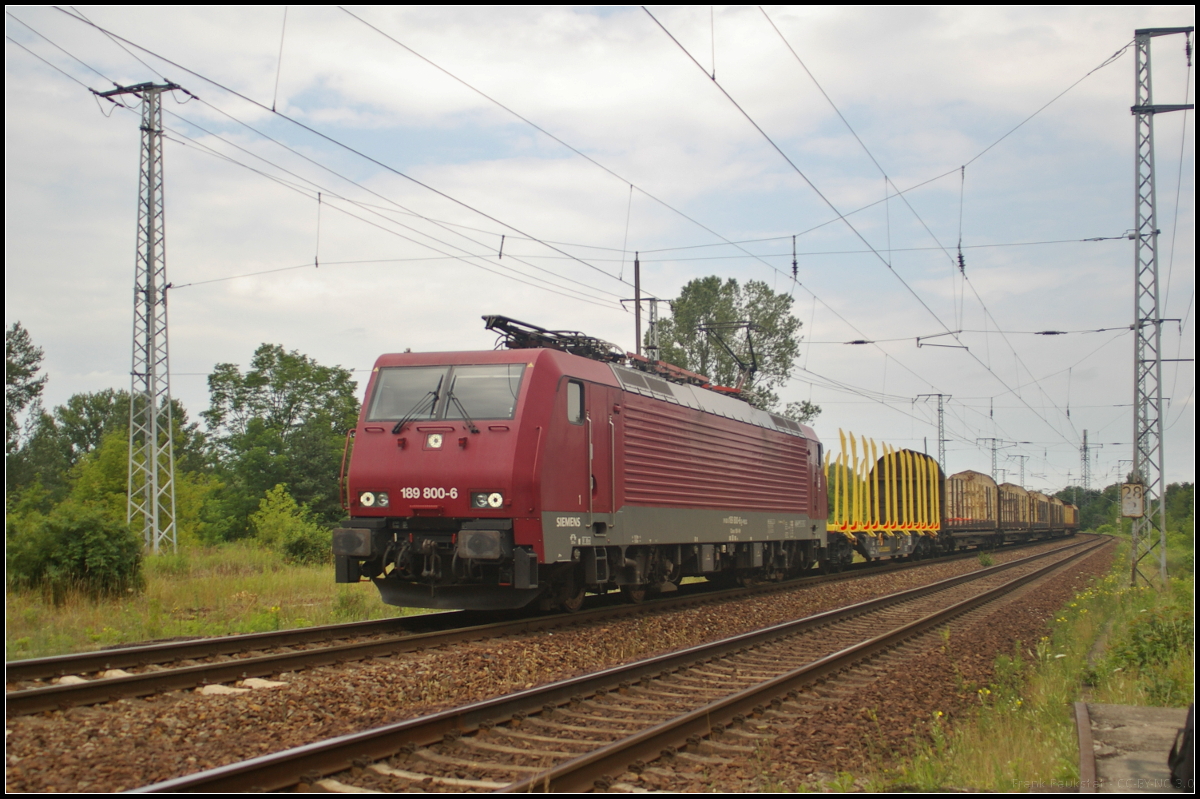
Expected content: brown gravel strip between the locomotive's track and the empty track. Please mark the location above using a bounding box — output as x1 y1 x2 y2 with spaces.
5 542 1089 792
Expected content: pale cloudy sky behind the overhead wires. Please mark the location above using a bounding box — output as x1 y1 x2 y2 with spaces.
5 6 1195 489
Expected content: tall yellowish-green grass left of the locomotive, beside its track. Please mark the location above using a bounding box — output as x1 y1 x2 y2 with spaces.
5 542 421 660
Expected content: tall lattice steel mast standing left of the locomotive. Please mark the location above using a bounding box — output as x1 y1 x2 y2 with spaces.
101 83 180 553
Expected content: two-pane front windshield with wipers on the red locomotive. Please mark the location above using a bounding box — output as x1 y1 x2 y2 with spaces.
367 364 524 421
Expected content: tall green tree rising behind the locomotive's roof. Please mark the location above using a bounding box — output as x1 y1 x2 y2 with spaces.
659 275 821 422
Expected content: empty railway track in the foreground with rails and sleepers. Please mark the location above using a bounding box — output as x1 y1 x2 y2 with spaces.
133 541 1110 792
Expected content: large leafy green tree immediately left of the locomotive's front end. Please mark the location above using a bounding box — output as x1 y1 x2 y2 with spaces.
200 344 359 539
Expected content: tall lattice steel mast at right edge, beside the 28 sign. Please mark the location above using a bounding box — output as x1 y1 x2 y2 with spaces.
1129 26 1195 587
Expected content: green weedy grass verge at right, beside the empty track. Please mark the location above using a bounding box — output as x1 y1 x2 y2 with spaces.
860 535 1195 792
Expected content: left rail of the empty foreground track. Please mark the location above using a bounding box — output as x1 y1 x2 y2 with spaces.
134 541 1106 793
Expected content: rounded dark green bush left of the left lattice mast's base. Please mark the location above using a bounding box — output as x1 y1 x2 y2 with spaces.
8 500 145 600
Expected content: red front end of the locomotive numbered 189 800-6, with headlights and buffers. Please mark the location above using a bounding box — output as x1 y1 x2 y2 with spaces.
334 352 540 609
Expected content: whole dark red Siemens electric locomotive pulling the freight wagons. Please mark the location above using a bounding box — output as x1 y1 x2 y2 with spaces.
334 317 827 609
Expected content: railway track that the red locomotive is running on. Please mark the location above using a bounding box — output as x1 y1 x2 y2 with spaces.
5 542 1084 717
